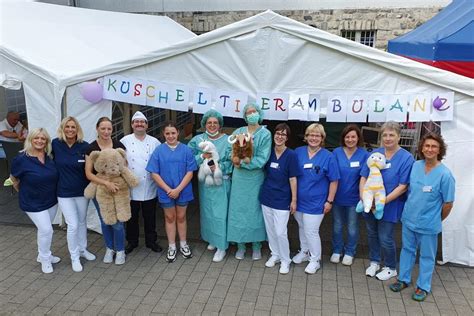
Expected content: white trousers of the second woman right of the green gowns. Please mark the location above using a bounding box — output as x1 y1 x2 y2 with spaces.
295 212 324 261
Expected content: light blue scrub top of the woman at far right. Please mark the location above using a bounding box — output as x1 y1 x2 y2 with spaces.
402 160 455 234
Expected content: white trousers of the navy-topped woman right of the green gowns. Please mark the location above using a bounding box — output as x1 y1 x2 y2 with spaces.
262 205 291 263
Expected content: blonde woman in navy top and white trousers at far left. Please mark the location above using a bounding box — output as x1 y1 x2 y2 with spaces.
10 128 61 273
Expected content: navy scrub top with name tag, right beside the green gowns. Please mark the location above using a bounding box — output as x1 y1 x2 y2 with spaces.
260 148 301 211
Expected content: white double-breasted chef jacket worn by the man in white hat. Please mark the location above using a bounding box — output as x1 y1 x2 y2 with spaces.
120 134 160 201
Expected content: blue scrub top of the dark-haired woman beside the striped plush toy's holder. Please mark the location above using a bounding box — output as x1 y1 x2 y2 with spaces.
332 147 368 206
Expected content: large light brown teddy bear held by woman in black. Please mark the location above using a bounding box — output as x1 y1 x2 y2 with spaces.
84 148 138 225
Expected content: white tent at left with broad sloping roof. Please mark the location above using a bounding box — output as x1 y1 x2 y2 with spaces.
0 0 196 138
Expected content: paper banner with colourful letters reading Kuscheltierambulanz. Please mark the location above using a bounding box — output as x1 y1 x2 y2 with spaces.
103 75 454 122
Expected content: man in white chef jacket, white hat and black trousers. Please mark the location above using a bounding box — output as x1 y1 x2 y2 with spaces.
120 111 162 254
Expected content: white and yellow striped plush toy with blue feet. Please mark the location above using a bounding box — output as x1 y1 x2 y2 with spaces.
356 152 386 219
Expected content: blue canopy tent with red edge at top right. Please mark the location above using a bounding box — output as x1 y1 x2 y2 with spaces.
388 0 474 78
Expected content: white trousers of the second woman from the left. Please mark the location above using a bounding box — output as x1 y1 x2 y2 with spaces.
58 196 89 260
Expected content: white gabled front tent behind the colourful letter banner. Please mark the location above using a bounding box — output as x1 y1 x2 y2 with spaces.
2 4 474 266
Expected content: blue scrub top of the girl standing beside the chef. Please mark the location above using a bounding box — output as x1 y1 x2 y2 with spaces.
146 143 197 203
